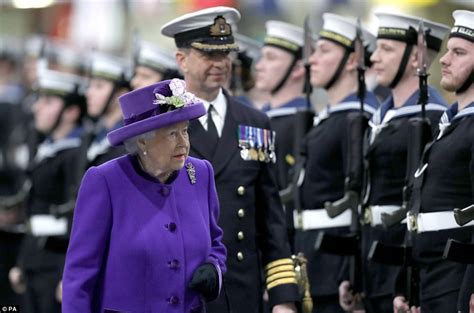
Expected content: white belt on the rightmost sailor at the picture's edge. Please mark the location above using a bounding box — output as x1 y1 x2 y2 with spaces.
407 211 474 233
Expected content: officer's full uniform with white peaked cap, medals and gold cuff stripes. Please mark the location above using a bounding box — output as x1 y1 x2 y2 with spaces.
161 7 298 313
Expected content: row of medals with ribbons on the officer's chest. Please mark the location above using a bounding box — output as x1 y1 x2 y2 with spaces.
237 125 276 163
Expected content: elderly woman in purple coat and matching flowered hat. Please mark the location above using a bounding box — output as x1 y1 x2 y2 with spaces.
62 79 226 313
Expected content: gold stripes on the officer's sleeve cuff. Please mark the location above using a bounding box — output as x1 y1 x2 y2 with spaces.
265 258 297 290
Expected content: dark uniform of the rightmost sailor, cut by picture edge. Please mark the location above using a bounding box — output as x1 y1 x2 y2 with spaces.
410 103 474 312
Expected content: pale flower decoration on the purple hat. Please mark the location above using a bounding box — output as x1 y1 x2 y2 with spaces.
153 78 198 111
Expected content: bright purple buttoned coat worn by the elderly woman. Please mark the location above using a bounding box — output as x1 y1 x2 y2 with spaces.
62 155 226 313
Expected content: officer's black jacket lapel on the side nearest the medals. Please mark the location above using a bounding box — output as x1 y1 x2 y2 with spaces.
211 94 239 176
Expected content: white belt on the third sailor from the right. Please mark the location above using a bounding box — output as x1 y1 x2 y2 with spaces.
293 209 352 230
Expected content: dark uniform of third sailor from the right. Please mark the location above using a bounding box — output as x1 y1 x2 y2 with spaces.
295 93 378 312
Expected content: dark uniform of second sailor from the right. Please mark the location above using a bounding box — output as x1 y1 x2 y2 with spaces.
362 87 446 312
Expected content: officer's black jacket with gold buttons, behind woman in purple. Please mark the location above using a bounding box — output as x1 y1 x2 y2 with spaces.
189 90 298 313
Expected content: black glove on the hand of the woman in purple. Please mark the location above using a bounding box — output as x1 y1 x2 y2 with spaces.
188 263 219 301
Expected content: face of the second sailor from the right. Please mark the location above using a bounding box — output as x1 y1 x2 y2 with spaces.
370 39 407 86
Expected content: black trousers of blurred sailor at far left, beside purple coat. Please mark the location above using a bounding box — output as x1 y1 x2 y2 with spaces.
22 269 61 313
